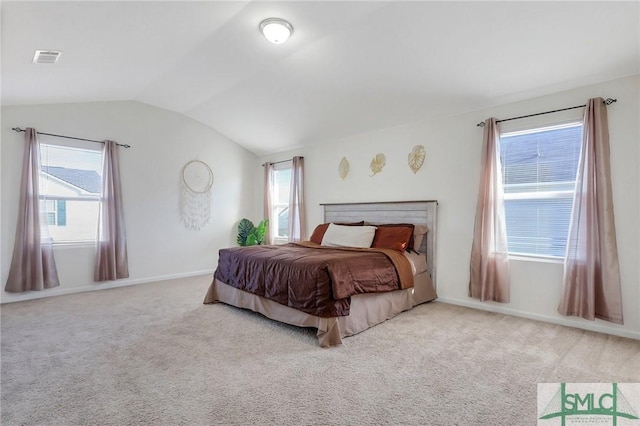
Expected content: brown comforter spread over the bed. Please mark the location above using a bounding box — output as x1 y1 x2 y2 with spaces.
215 242 413 317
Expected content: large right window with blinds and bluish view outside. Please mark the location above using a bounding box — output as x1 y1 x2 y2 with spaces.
500 122 582 257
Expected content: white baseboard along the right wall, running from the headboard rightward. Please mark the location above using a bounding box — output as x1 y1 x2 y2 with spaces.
437 297 640 340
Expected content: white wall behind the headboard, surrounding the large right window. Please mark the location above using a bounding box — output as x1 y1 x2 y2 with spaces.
256 76 640 338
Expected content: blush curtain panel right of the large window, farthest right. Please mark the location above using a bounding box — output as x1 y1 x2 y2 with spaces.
558 98 623 324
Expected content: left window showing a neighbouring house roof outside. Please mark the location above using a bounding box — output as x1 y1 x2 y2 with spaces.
40 143 102 243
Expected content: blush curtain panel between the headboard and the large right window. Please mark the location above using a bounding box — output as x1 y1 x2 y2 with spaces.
469 118 510 303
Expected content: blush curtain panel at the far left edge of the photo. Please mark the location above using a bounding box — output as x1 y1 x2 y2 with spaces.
5 127 60 293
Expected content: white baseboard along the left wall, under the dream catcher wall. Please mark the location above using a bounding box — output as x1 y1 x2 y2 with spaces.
0 269 214 304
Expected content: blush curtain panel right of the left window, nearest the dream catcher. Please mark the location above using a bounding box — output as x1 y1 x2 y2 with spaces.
93 141 129 282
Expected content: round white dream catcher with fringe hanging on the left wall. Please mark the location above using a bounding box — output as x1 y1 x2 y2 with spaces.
181 160 213 230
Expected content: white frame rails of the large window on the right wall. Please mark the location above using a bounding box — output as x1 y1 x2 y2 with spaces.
499 117 584 263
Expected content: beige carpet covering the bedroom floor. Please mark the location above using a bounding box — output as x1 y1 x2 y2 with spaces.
1 277 640 426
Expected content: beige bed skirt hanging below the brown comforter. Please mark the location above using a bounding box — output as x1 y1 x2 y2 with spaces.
204 272 437 347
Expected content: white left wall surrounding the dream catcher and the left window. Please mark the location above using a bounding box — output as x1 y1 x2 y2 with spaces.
0 102 260 302
